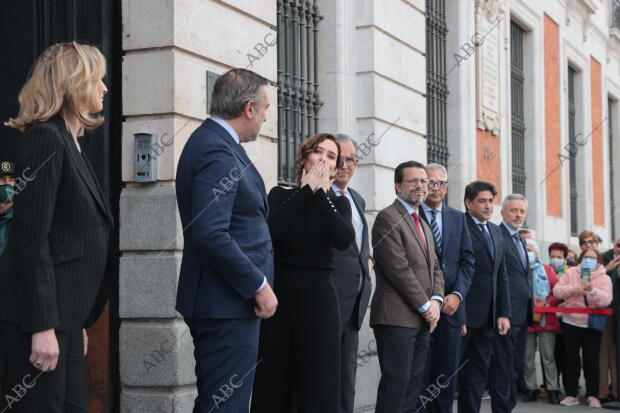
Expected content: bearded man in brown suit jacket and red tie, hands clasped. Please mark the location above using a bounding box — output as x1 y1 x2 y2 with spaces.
370 161 443 413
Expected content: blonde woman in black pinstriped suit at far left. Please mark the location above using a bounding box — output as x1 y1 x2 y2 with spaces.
0 42 113 413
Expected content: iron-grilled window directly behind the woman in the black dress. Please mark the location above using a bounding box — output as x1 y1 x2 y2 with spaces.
277 0 322 186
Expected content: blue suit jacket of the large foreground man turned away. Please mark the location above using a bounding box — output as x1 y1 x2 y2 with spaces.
176 119 273 319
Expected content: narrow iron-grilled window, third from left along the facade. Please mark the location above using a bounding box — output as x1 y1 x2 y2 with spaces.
510 22 526 195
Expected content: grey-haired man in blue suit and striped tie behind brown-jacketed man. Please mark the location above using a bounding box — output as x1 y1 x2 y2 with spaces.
418 164 475 413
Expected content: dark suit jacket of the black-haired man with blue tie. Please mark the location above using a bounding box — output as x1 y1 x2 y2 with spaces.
465 214 511 328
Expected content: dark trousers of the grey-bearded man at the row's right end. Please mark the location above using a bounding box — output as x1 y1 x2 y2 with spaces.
490 326 527 413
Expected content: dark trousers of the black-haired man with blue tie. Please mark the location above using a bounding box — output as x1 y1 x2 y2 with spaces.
458 322 495 413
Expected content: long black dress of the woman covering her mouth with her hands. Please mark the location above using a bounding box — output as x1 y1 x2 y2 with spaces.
252 185 355 413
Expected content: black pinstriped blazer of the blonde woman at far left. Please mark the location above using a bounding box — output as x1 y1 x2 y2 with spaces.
0 116 113 332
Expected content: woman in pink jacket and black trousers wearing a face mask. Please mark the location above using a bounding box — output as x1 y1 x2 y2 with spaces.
553 248 611 407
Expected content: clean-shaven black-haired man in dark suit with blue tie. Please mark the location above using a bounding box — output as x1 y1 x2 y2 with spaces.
458 181 511 413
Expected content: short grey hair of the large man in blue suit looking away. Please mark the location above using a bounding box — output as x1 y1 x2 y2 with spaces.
210 69 269 119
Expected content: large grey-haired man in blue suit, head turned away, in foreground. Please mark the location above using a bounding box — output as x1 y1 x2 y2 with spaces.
176 69 277 413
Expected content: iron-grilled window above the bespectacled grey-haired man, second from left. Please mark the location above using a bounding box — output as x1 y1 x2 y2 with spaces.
426 0 448 166
